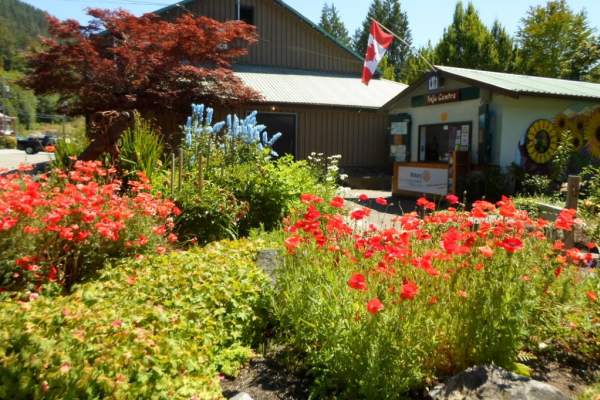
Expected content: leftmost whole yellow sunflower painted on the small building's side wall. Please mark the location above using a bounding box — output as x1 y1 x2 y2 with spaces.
525 119 560 164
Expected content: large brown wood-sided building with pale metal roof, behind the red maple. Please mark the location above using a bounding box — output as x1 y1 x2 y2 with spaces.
156 0 406 170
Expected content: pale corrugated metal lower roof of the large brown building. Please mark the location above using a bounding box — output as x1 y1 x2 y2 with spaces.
233 65 407 109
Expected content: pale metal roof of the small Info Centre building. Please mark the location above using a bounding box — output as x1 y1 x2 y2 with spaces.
435 65 600 99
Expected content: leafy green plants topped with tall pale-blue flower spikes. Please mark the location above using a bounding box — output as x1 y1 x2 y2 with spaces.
174 106 339 243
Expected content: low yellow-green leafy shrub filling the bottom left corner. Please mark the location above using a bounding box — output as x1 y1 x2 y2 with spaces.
0 241 267 400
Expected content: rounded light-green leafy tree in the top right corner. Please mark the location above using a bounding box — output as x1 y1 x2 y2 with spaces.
518 0 600 79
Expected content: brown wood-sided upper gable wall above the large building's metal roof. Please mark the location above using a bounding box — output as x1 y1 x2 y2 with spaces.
162 0 362 74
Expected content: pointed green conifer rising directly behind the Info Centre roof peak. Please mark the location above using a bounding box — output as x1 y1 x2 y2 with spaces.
435 1 500 70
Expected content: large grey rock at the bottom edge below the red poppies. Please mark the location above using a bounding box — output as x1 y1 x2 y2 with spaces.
429 365 568 400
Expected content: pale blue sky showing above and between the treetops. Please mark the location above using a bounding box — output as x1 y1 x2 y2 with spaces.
25 0 600 46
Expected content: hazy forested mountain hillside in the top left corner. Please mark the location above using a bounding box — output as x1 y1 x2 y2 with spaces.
0 0 48 70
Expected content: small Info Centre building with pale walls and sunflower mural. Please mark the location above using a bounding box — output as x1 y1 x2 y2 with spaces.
384 66 600 195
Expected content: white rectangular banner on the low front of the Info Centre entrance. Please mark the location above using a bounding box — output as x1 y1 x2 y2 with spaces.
398 167 448 196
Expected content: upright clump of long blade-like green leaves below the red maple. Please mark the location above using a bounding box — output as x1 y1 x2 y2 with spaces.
119 112 163 182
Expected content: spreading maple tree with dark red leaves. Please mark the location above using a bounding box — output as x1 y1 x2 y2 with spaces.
24 9 260 115
